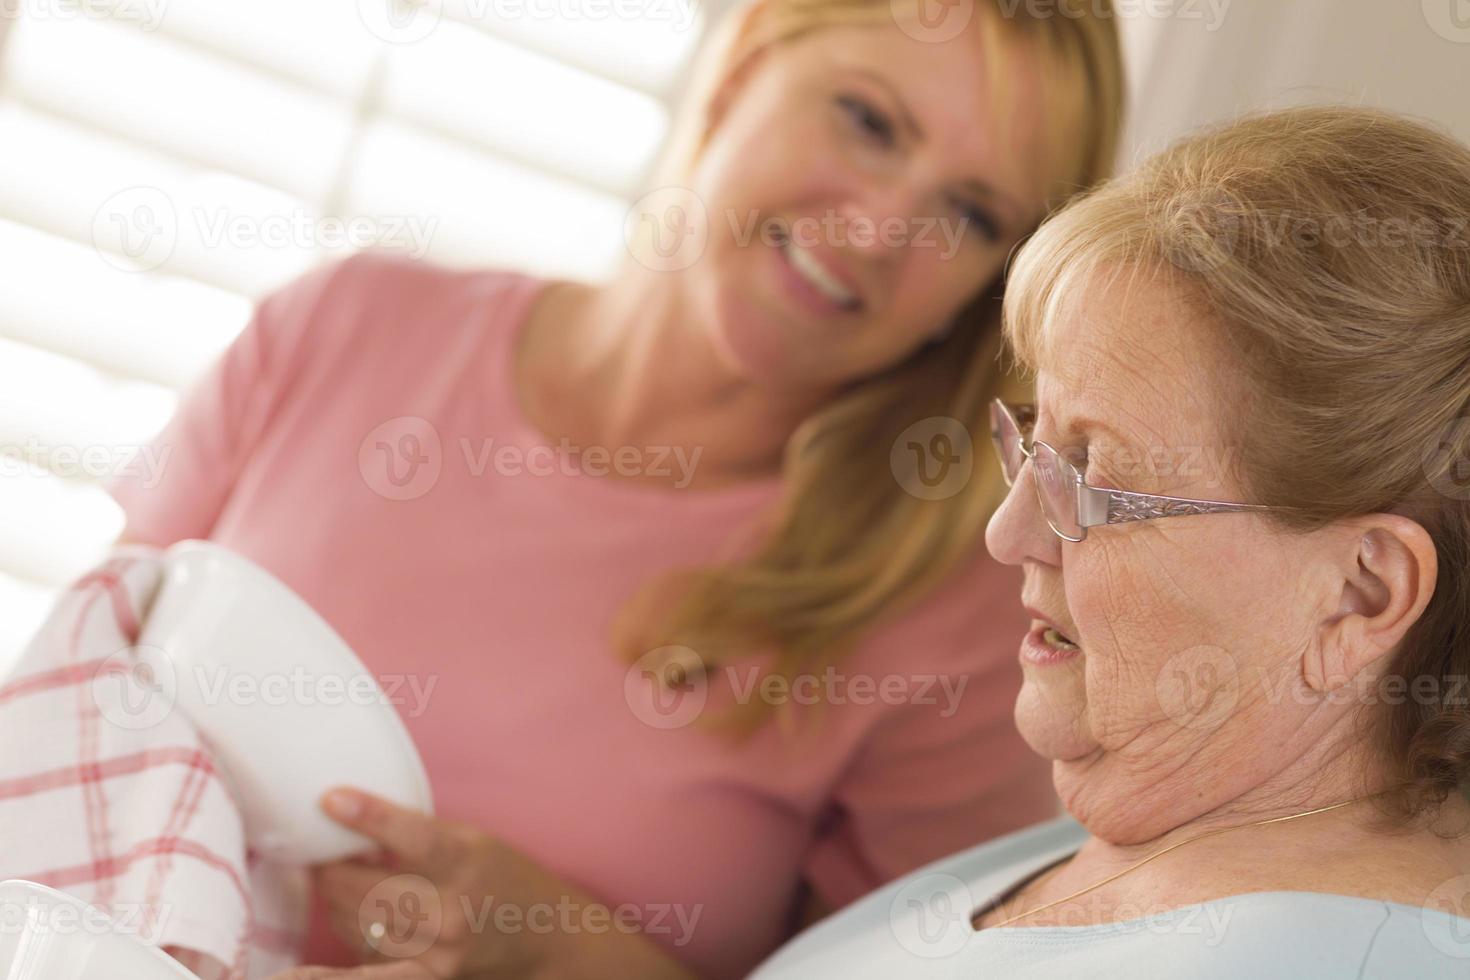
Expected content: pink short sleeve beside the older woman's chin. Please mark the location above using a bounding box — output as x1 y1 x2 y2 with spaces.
803 558 1058 908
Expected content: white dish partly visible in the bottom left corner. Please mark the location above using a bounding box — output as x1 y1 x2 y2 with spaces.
0 879 198 980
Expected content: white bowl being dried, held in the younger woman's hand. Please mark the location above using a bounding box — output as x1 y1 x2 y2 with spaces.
138 541 434 864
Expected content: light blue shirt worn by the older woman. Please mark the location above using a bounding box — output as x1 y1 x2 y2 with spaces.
751 817 1470 980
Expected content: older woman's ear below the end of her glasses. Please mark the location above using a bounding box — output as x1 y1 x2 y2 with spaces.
1302 514 1439 693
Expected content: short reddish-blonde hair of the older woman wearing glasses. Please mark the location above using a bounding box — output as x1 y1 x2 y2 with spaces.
1004 107 1470 818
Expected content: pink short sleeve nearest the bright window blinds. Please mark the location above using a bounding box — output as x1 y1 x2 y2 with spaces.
104 256 362 547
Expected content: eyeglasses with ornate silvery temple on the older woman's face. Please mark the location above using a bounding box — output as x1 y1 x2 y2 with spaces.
991 398 1276 541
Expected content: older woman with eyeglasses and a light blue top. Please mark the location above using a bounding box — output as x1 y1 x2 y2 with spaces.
756 109 1470 980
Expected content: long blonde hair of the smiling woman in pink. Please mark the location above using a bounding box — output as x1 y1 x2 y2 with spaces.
614 0 1123 733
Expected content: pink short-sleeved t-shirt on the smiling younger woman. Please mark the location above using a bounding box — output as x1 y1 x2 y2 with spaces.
109 253 1055 977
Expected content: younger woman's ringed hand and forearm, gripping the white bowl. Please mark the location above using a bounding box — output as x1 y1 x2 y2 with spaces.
313 789 689 980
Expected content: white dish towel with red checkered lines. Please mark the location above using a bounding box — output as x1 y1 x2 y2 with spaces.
0 545 307 980
